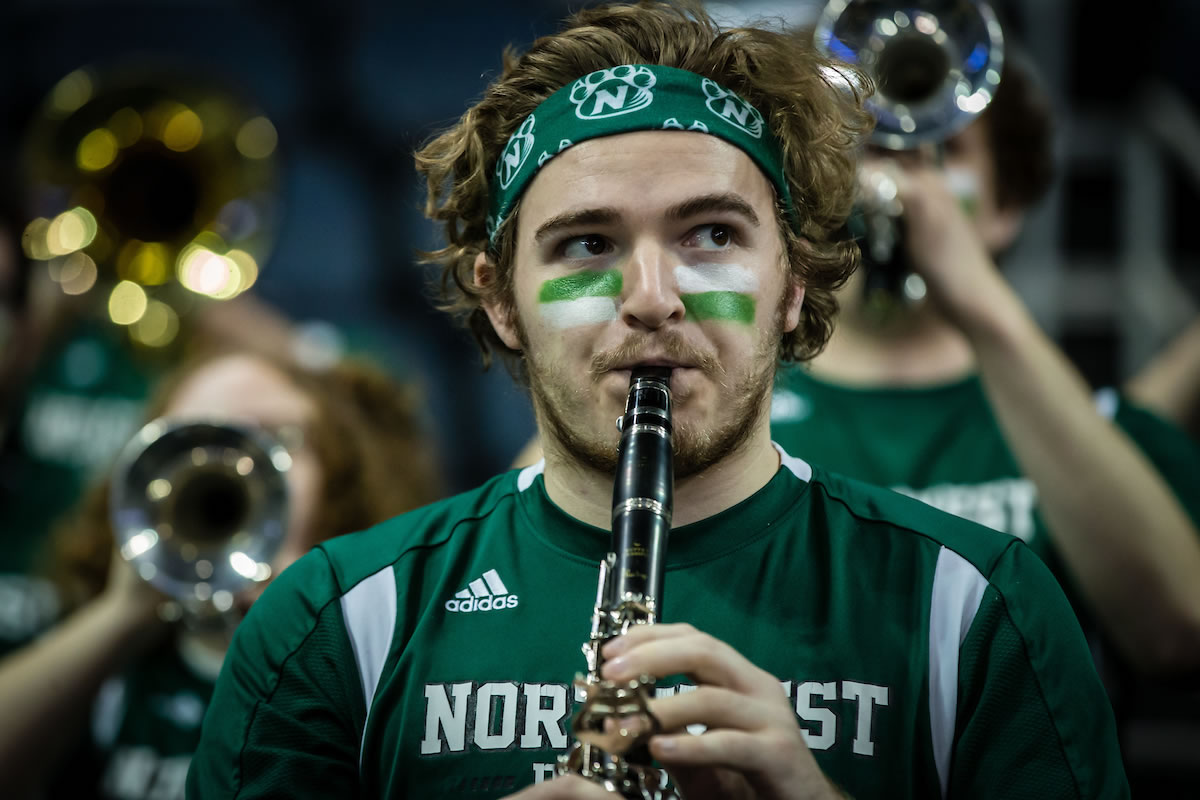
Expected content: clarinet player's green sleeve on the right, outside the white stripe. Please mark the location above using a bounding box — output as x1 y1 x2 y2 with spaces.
948 542 1129 800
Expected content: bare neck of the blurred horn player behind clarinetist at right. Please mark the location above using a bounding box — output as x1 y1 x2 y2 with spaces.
811 276 974 386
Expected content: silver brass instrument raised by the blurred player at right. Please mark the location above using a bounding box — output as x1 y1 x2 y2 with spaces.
814 0 1004 318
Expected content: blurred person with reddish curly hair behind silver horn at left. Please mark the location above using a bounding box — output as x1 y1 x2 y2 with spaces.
0 348 437 800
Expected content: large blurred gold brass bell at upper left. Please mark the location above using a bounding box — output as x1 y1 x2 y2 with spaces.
22 62 277 348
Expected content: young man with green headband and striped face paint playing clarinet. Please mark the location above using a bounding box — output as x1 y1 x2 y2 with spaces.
188 5 1128 800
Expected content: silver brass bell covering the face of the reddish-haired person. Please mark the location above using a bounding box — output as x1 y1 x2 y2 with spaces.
109 419 292 624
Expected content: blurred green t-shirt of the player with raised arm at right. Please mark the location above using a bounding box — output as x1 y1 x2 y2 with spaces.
770 367 1200 587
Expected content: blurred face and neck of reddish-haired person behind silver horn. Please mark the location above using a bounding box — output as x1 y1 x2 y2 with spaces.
163 355 324 614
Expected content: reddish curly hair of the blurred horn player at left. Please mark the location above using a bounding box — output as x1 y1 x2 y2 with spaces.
44 347 442 609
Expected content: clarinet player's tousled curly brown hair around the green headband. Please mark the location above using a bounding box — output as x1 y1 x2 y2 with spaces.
416 1 874 377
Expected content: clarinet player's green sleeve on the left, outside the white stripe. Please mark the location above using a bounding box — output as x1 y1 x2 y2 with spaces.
187 551 366 800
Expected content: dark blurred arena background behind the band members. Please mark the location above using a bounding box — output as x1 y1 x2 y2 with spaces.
0 0 1200 489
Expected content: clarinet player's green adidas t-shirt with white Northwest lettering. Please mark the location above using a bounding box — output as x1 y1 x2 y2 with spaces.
188 455 1128 800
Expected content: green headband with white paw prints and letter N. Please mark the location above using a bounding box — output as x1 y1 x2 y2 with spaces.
487 64 796 243
